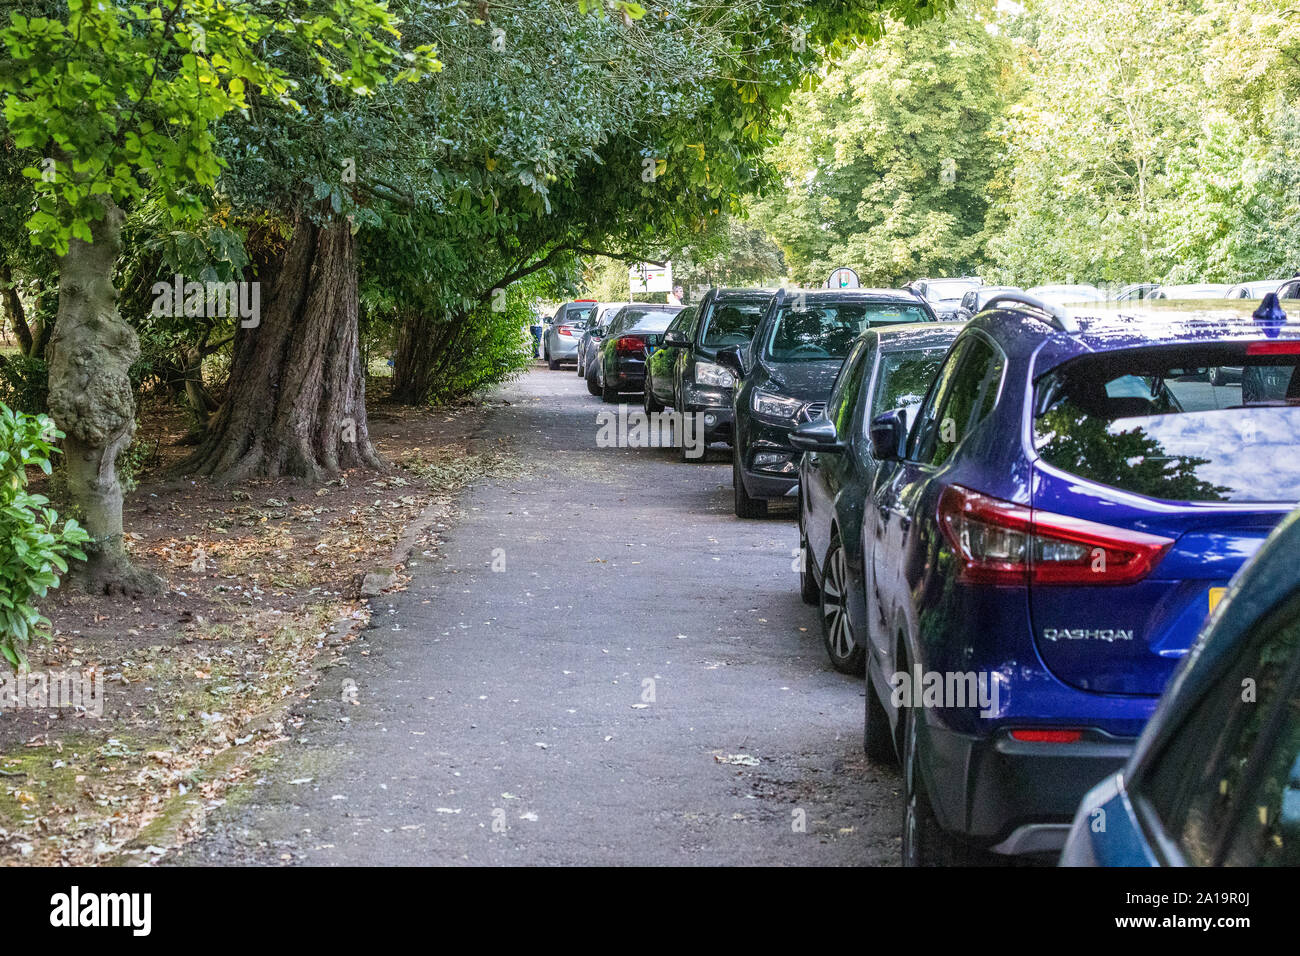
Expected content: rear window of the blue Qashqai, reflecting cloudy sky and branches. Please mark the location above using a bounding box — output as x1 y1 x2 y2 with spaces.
1034 342 1300 503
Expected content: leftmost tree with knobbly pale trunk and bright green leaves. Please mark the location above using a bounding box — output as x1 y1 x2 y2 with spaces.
0 0 430 592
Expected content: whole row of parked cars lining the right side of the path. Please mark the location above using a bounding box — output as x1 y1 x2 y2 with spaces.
546 287 1300 865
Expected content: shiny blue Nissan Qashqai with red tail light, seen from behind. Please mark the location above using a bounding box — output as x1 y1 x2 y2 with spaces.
862 293 1300 865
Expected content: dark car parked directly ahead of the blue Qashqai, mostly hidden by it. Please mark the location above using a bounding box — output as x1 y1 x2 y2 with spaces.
790 323 963 676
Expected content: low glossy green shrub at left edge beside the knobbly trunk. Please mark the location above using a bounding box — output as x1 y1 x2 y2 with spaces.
0 403 90 669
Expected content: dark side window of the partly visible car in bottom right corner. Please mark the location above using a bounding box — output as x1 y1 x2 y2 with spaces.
1135 600 1300 866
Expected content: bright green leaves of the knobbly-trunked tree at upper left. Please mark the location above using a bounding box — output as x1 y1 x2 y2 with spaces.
0 0 430 255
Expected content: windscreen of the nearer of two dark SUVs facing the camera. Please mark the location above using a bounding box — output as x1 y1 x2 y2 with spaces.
766 303 930 362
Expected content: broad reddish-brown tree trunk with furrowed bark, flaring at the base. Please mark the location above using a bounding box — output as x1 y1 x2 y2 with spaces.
177 217 384 483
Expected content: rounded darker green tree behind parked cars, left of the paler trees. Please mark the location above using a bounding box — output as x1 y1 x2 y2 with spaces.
757 4 1009 285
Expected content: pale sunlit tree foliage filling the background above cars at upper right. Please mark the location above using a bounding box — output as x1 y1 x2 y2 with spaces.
757 0 1300 285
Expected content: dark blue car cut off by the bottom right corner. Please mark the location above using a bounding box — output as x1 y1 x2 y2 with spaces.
1061 511 1300 866
